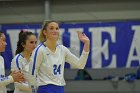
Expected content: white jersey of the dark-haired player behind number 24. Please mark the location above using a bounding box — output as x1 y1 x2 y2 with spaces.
11 54 31 93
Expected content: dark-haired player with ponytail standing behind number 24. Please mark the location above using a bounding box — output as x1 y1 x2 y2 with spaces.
11 31 37 93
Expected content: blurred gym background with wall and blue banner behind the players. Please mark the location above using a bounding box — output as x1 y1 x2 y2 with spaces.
0 0 140 93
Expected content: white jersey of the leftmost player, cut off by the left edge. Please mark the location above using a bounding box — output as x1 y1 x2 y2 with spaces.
0 55 14 93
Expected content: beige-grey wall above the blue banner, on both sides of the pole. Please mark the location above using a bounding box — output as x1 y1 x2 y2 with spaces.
0 0 140 24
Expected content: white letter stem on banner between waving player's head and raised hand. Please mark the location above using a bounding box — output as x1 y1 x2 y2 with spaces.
68 28 83 68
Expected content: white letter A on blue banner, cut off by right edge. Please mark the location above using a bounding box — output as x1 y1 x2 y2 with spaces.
126 26 140 67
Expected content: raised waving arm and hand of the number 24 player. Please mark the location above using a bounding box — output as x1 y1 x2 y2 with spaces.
65 32 90 69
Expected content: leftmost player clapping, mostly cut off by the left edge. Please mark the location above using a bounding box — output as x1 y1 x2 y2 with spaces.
0 31 25 93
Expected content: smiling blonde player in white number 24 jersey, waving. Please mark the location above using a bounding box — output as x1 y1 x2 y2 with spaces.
29 21 90 93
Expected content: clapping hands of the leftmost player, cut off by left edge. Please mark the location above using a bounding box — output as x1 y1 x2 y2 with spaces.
11 71 25 82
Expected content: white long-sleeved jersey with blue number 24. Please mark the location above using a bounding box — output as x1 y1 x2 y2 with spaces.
29 43 89 86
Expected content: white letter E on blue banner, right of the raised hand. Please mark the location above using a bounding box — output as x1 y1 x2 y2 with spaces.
89 27 116 68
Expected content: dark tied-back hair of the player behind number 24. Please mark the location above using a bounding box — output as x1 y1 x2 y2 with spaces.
16 30 35 54
